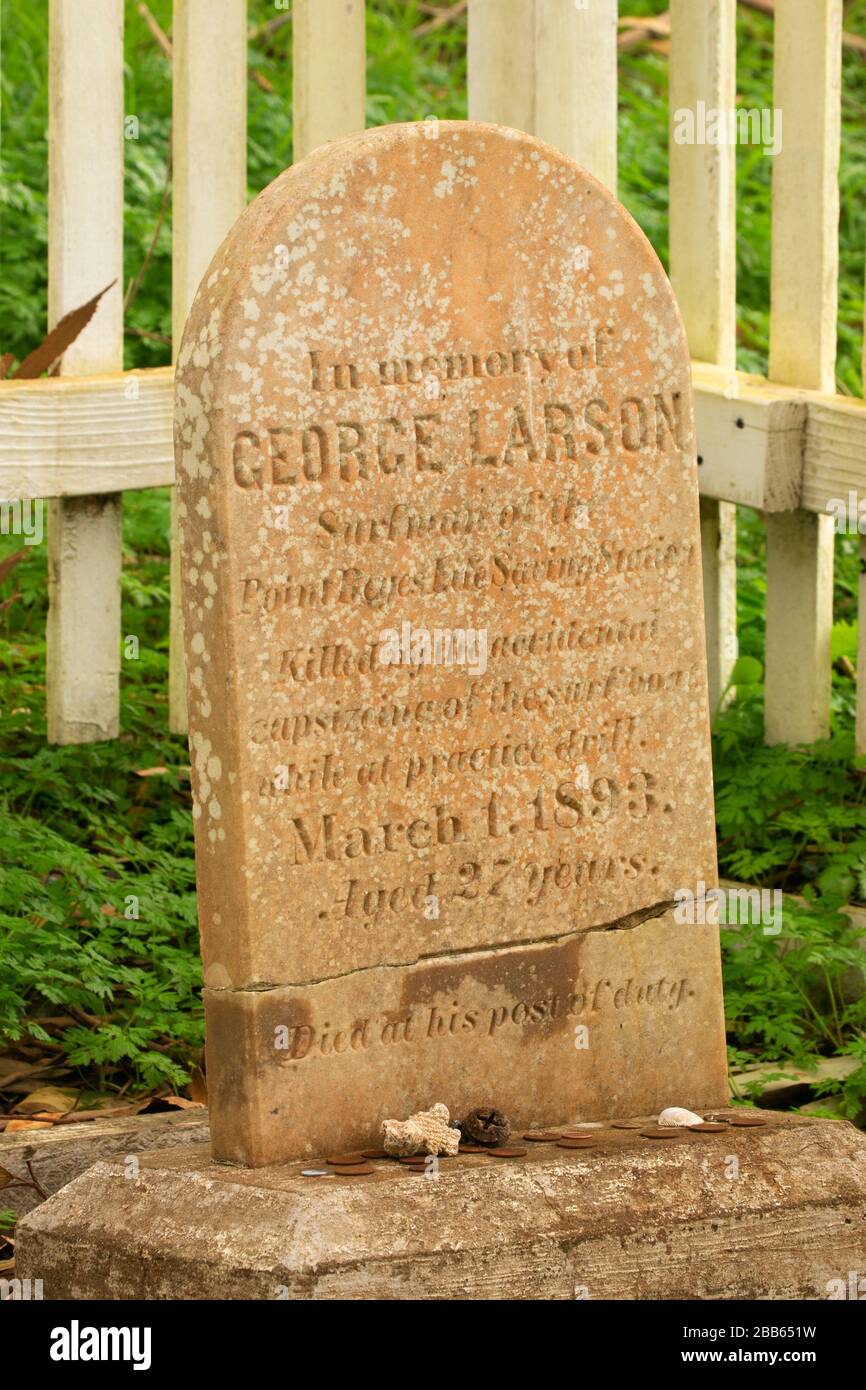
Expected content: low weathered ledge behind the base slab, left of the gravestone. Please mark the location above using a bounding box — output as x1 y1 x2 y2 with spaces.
0 1111 210 1215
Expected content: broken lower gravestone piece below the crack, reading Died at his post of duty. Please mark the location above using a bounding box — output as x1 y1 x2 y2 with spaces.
207 913 727 1163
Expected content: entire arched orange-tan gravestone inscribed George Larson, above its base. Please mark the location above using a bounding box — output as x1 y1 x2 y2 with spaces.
177 121 724 1163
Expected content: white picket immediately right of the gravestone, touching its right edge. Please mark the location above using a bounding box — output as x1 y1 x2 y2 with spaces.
670 0 737 712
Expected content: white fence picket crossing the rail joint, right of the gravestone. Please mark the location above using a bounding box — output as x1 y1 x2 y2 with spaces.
765 0 842 744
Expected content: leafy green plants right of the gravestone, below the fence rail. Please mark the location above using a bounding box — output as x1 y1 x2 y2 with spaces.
713 509 866 1123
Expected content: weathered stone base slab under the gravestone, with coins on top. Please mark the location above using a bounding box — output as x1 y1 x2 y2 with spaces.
17 1111 866 1300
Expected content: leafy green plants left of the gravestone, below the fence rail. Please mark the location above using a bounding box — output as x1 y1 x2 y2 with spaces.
0 491 193 1091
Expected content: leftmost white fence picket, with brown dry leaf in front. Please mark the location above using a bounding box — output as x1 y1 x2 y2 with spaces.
46 0 124 744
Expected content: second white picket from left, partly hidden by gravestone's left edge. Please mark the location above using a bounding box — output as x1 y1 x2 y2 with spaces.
168 0 246 734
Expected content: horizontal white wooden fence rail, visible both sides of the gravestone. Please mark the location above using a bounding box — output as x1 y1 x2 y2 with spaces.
6 361 866 516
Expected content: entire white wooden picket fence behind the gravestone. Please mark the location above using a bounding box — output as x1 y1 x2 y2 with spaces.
0 0 866 752
